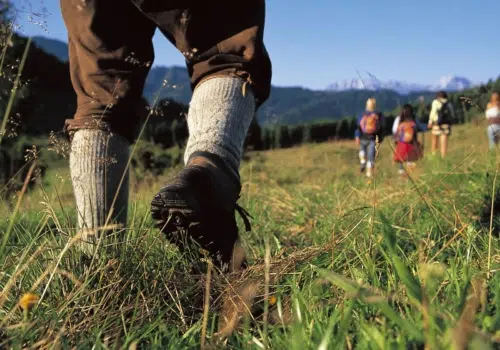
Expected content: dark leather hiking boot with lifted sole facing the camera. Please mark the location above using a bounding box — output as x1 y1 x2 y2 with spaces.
151 152 251 272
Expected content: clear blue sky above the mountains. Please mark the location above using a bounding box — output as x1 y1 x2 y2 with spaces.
9 0 500 89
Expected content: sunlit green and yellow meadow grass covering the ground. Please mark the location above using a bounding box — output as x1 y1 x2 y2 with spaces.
0 121 500 349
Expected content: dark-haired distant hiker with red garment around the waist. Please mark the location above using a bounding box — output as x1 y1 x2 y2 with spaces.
393 104 427 175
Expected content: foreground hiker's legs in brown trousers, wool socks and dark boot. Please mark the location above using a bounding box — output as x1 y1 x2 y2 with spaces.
61 0 271 270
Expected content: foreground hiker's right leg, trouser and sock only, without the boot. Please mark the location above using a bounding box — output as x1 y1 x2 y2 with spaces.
135 0 271 178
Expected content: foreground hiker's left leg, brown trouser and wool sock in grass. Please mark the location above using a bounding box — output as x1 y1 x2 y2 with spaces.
61 0 155 232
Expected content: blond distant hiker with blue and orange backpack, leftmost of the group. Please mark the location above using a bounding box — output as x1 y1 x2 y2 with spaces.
354 98 384 177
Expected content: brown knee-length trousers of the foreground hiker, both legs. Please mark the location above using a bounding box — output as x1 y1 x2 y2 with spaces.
61 0 271 142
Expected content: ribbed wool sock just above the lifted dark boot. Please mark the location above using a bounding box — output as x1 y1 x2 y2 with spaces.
184 76 255 179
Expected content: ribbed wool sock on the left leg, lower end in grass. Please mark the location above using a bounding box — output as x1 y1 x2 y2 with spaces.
69 130 130 229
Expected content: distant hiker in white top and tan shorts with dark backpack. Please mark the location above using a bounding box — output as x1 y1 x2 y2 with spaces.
428 91 455 158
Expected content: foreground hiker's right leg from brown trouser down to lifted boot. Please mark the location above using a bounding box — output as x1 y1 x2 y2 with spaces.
141 0 271 264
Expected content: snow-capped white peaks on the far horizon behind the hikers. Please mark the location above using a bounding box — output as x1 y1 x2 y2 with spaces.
326 75 474 95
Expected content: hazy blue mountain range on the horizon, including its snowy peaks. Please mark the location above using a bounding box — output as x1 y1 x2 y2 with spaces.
33 37 484 124
